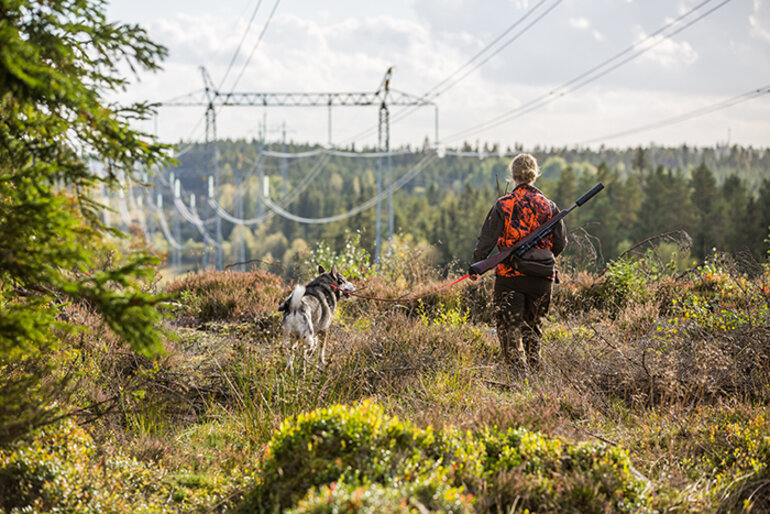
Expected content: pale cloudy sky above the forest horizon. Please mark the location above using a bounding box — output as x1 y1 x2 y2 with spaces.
107 0 770 150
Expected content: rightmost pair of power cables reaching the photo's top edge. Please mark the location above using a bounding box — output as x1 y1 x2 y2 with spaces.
446 0 732 141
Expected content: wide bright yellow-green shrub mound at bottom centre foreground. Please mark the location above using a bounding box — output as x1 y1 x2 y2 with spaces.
241 401 647 512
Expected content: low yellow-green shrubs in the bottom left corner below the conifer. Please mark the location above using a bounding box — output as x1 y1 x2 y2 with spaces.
0 420 251 513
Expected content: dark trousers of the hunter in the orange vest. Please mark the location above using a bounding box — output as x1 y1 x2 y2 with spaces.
494 277 553 370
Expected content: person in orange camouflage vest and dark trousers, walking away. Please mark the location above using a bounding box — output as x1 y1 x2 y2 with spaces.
469 153 567 371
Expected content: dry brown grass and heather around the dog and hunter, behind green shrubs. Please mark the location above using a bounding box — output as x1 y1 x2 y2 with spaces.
7 258 770 511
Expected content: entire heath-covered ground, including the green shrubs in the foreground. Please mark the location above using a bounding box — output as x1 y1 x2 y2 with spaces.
0 246 770 512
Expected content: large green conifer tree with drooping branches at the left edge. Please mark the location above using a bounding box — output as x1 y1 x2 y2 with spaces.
0 0 166 444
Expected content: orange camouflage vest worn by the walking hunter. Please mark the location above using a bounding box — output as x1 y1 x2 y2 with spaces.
495 184 553 277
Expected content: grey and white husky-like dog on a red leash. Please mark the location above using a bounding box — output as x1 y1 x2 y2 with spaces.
278 266 356 369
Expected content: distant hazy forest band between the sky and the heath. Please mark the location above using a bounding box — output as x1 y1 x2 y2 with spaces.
154 140 770 276
